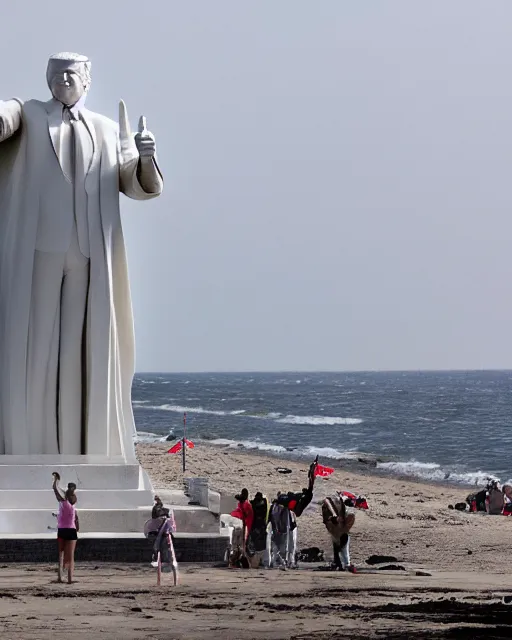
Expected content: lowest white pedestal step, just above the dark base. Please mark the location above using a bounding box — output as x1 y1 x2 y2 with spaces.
0 505 220 535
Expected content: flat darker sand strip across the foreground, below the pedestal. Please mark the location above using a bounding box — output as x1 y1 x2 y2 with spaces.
0 564 512 640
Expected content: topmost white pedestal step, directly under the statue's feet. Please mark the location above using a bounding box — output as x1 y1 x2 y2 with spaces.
0 456 145 491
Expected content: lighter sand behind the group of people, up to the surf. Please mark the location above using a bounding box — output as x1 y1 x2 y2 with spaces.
138 444 512 576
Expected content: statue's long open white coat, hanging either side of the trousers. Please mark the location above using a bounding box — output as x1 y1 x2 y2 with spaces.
0 100 162 461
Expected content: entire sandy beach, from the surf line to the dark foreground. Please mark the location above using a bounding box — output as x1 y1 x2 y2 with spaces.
0 444 512 640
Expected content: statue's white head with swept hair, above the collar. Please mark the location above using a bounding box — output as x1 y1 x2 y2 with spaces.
46 52 91 107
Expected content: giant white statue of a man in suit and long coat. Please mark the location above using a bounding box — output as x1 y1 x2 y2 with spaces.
0 53 163 461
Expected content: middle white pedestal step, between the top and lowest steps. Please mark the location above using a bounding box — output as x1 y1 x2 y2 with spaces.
0 489 154 511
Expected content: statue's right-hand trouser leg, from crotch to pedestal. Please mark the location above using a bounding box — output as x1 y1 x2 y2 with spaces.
58 229 89 454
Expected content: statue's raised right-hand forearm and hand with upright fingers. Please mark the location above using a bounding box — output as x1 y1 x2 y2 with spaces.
119 100 163 200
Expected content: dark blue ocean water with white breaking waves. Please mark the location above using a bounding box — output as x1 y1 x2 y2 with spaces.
133 371 512 485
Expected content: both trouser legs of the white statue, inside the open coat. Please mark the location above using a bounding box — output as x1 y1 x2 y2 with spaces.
27 231 89 454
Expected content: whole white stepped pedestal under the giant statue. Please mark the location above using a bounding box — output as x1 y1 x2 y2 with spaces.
0 456 229 562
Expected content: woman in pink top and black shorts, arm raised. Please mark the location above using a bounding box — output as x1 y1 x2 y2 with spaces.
52 473 78 584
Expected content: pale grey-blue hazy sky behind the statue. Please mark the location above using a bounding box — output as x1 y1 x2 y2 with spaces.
0 0 512 371
